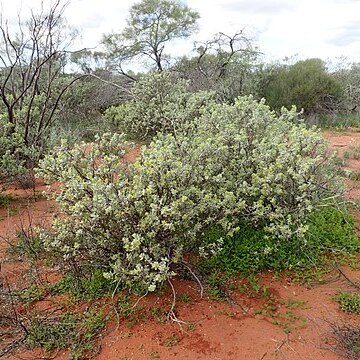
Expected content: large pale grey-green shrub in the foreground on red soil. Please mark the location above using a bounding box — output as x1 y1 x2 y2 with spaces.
38 98 339 291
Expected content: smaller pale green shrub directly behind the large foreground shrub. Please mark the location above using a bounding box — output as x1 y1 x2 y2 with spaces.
105 71 214 141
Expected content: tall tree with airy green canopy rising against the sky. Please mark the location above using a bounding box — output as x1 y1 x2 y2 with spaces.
104 0 199 73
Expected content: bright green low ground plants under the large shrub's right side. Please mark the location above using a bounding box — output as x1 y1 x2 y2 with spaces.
198 206 360 278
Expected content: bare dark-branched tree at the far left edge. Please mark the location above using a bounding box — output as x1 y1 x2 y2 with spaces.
0 0 83 184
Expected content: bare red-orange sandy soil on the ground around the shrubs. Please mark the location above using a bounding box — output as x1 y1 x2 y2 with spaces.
0 139 360 360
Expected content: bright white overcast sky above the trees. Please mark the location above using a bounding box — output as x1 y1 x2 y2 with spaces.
0 0 360 62
